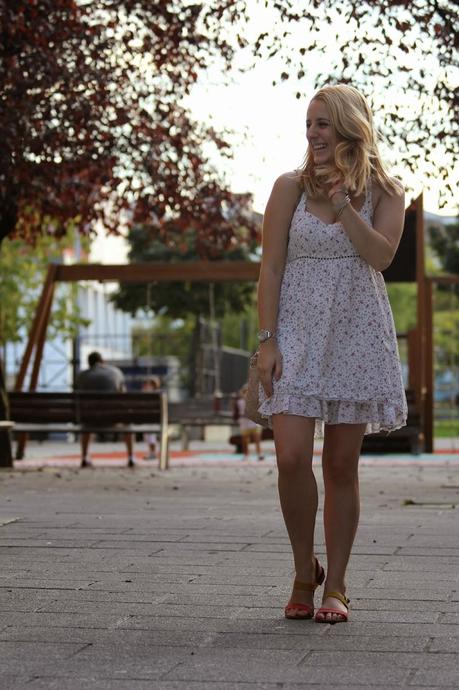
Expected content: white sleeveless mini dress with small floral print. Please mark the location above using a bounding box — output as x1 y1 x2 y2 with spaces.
259 179 407 435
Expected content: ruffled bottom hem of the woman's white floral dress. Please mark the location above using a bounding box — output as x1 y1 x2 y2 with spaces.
258 392 407 437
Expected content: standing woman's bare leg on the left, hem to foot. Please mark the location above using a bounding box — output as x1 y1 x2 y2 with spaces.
273 415 317 605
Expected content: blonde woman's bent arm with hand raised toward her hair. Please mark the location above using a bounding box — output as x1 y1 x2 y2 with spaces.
329 179 405 271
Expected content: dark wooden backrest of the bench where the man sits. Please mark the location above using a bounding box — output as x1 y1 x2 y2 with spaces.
9 390 167 426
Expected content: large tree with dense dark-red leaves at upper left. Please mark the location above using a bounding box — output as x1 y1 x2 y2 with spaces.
0 0 257 418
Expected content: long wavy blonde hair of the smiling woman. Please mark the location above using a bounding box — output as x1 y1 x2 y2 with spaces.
299 84 400 197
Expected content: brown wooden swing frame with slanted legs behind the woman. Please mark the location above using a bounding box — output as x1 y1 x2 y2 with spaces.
9 195 458 452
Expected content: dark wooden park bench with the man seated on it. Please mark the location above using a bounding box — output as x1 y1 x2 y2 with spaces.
0 390 169 470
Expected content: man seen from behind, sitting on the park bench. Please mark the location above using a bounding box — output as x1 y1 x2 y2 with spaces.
75 352 134 467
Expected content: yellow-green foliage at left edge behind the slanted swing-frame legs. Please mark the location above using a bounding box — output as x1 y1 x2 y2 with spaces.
0 236 87 347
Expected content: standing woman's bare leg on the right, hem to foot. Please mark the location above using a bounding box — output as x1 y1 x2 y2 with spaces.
322 424 366 622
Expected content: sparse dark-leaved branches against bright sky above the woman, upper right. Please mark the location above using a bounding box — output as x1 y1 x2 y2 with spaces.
255 0 459 205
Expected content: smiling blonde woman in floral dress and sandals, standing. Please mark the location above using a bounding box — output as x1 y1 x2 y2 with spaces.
258 84 407 623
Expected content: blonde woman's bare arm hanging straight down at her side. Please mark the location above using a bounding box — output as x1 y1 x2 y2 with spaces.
258 173 301 396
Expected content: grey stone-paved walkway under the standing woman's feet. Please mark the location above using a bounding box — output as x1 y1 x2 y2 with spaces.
0 438 459 690
